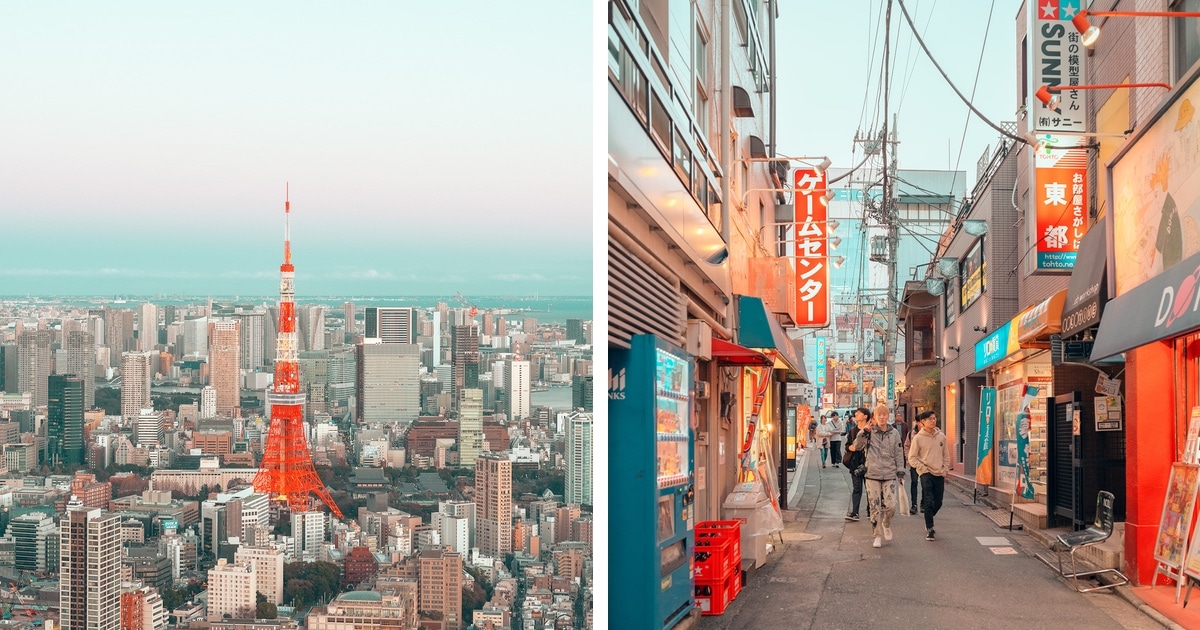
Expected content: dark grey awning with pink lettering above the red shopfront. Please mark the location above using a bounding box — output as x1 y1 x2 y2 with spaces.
1092 248 1200 361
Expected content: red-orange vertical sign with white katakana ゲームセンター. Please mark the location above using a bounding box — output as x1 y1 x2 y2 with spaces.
793 168 829 328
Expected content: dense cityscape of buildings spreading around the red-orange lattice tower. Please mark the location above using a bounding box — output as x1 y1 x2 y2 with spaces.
0 265 593 630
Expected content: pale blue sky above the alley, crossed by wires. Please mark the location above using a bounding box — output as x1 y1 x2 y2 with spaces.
776 0 1027 192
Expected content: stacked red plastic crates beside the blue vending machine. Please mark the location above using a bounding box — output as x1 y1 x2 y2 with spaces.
692 521 742 614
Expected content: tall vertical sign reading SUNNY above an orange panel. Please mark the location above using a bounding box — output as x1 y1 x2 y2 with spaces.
1027 0 1088 271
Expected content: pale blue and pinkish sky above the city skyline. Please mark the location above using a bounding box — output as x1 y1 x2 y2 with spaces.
0 0 593 295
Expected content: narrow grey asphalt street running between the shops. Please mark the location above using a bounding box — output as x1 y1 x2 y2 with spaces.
700 452 1184 630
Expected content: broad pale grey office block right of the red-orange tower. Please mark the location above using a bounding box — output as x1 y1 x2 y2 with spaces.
355 343 421 426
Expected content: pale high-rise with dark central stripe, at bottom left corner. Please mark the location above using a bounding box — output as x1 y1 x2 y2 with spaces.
59 504 121 630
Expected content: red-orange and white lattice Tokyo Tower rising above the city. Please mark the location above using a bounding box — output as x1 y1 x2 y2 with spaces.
253 186 342 518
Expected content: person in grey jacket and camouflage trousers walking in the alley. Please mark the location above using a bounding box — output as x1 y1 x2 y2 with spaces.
854 406 906 547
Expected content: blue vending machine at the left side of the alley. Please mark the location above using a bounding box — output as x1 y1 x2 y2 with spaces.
608 335 696 629
